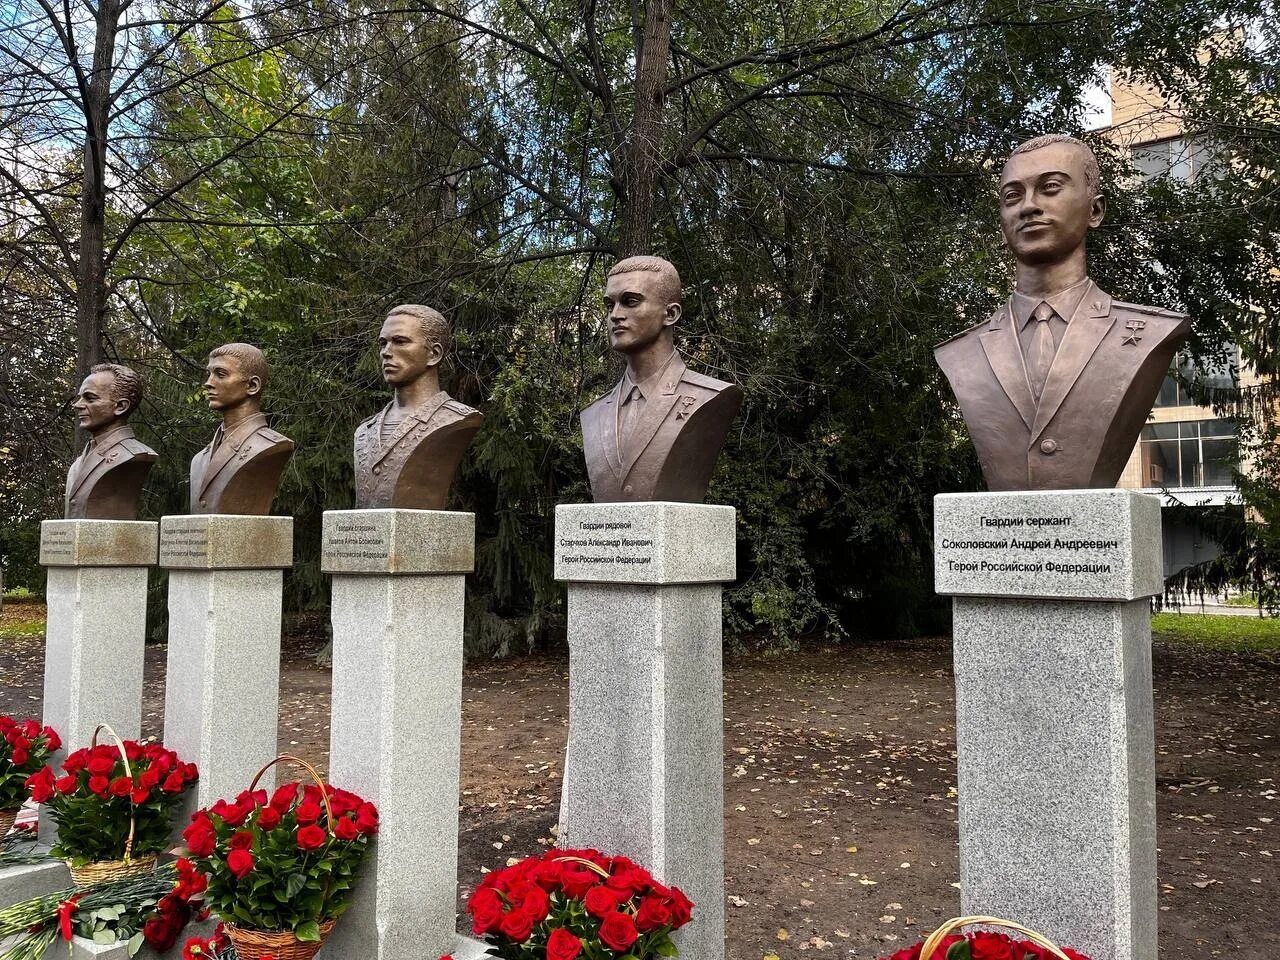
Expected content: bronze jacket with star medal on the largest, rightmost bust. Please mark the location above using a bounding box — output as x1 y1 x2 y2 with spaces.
934 282 1190 490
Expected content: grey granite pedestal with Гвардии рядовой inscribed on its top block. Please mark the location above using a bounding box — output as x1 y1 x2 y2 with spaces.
556 503 737 960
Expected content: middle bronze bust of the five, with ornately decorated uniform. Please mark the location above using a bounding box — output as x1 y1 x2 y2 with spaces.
356 303 484 509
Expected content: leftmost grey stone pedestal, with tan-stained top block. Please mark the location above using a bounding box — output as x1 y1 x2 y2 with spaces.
33 520 159 865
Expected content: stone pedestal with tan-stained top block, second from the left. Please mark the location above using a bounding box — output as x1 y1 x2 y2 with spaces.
160 513 293 814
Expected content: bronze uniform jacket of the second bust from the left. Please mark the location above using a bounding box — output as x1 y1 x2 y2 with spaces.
191 413 293 516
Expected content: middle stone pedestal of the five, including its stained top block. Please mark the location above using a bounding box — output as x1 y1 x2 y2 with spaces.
321 509 475 960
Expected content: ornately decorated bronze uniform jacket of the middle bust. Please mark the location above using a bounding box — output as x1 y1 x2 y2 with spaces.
356 390 484 509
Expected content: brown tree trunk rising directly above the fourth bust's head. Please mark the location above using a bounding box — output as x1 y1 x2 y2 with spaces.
618 0 673 257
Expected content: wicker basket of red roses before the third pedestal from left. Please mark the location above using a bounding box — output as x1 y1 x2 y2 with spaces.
183 758 378 960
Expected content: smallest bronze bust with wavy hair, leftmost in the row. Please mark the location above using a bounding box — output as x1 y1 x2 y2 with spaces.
64 364 159 520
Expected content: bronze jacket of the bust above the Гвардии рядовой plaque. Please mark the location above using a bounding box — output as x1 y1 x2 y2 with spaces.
582 353 742 503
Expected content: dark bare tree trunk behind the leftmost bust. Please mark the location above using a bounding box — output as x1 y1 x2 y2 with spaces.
76 0 120 379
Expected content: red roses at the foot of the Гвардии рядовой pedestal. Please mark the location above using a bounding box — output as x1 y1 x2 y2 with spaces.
467 850 694 960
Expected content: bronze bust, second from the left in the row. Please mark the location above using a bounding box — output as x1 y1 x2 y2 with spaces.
191 343 293 516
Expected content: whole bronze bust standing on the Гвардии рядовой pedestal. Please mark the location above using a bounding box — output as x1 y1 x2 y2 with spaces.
582 256 742 503
